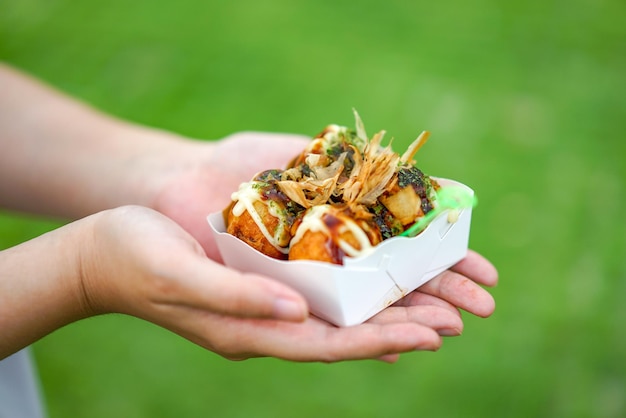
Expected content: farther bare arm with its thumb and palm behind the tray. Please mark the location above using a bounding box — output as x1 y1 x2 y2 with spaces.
0 63 307 260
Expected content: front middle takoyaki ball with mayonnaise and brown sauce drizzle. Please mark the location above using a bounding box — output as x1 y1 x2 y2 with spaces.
289 205 382 264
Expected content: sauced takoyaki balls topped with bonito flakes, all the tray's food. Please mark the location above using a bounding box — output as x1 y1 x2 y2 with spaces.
225 112 440 264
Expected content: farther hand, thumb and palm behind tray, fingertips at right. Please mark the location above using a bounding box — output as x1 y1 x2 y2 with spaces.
149 132 498 334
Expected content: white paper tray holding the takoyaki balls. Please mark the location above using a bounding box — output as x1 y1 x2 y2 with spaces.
207 179 473 326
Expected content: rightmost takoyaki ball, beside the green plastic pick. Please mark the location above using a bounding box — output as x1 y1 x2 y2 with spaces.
378 166 439 226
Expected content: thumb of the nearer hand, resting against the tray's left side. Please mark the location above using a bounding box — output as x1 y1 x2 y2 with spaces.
161 253 308 321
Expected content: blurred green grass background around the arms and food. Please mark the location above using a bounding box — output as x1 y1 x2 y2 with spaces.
0 0 626 418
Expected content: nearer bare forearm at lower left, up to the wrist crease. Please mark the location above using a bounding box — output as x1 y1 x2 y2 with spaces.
0 220 89 359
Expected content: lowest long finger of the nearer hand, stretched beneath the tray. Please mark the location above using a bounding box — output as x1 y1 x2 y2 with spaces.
186 317 442 363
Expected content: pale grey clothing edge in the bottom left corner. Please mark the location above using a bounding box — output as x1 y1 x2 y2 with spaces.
0 349 46 418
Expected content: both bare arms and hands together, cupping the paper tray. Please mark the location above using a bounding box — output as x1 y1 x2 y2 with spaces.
0 64 498 362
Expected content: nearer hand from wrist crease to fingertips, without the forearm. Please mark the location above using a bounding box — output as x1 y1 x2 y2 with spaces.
80 207 462 362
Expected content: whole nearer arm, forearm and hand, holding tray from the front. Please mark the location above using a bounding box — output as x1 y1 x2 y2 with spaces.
0 206 448 361
